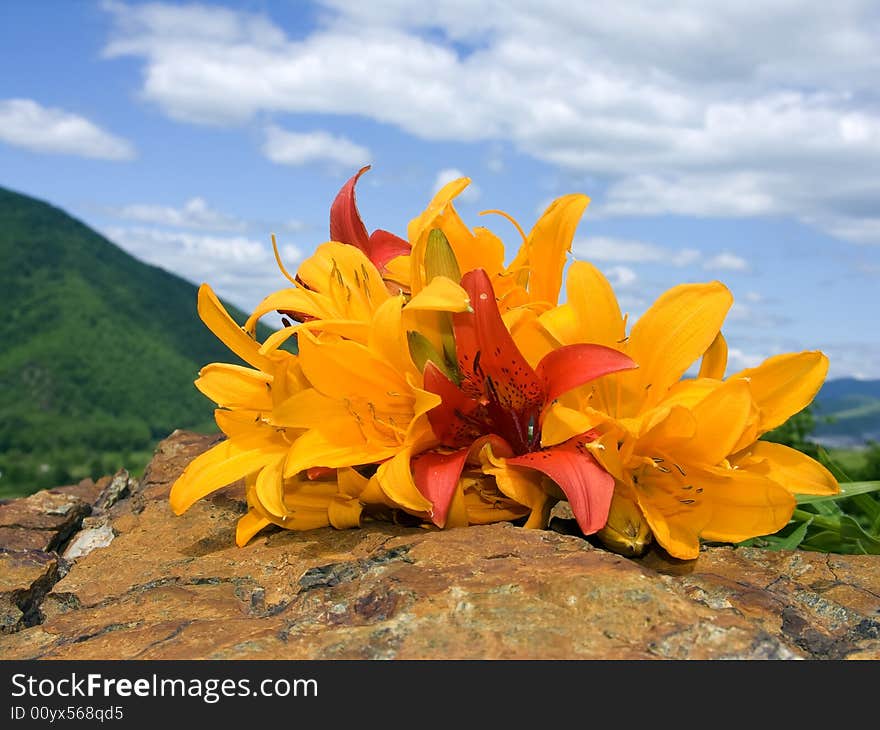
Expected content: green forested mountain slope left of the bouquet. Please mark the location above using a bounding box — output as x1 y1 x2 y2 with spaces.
0 188 266 492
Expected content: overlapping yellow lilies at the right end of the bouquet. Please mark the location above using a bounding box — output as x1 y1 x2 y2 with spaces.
540 263 839 559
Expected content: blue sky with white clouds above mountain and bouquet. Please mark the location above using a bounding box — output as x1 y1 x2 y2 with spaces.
0 0 880 378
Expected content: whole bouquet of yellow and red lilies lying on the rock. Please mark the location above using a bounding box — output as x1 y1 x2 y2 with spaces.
170 167 839 559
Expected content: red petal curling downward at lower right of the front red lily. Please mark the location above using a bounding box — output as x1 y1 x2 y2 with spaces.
507 437 614 535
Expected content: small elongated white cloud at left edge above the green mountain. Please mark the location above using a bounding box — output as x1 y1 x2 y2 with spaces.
0 99 135 160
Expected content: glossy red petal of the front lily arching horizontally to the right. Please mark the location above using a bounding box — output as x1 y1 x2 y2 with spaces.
535 344 636 403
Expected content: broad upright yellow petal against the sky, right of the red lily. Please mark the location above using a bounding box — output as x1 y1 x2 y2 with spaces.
626 281 733 405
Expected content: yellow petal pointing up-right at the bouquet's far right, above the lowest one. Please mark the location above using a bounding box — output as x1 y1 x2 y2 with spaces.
729 350 828 434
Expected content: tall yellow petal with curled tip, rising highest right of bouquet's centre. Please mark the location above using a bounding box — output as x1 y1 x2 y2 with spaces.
528 194 590 306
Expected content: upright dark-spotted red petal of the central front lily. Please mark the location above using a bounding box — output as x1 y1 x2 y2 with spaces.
452 269 544 413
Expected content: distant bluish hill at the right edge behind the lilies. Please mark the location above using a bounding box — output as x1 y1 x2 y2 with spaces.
813 378 880 446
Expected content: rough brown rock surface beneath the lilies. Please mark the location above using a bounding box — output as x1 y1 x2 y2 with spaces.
0 432 880 659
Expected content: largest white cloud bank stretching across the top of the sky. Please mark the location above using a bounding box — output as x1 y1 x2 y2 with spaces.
105 0 880 243
